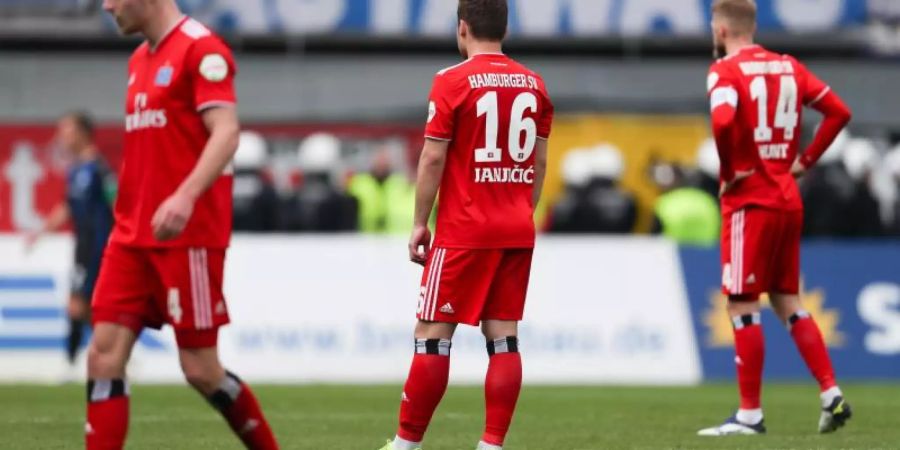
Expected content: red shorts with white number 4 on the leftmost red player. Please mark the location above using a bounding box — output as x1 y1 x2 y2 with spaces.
91 243 229 348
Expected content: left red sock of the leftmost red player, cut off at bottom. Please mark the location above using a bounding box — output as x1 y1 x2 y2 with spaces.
84 379 128 450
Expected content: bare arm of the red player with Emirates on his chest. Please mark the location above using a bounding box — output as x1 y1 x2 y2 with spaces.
153 106 240 241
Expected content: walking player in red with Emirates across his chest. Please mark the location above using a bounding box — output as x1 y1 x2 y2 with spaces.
85 0 278 450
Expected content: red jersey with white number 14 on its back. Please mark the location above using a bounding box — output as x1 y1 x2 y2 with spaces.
707 45 830 214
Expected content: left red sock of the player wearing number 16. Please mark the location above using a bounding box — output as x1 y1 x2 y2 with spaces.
397 339 450 442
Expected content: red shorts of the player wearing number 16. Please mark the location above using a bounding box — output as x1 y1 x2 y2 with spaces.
416 248 534 325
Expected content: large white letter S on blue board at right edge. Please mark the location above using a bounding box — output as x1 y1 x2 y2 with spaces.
856 283 900 355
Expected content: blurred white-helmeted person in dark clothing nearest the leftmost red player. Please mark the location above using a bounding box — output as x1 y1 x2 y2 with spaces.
234 131 279 232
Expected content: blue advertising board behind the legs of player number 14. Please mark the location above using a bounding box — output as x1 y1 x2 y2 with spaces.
680 243 900 380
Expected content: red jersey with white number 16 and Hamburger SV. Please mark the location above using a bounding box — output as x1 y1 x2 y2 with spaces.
425 54 553 249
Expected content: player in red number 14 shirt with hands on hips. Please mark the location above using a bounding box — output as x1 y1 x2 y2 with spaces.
700 0 851 436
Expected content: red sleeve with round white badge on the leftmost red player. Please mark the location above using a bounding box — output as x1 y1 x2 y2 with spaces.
187 37 237 111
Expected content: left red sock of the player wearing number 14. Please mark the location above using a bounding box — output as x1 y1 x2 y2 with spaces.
732 313 766 410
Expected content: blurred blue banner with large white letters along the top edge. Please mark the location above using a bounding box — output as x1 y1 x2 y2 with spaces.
158 0 867 38
